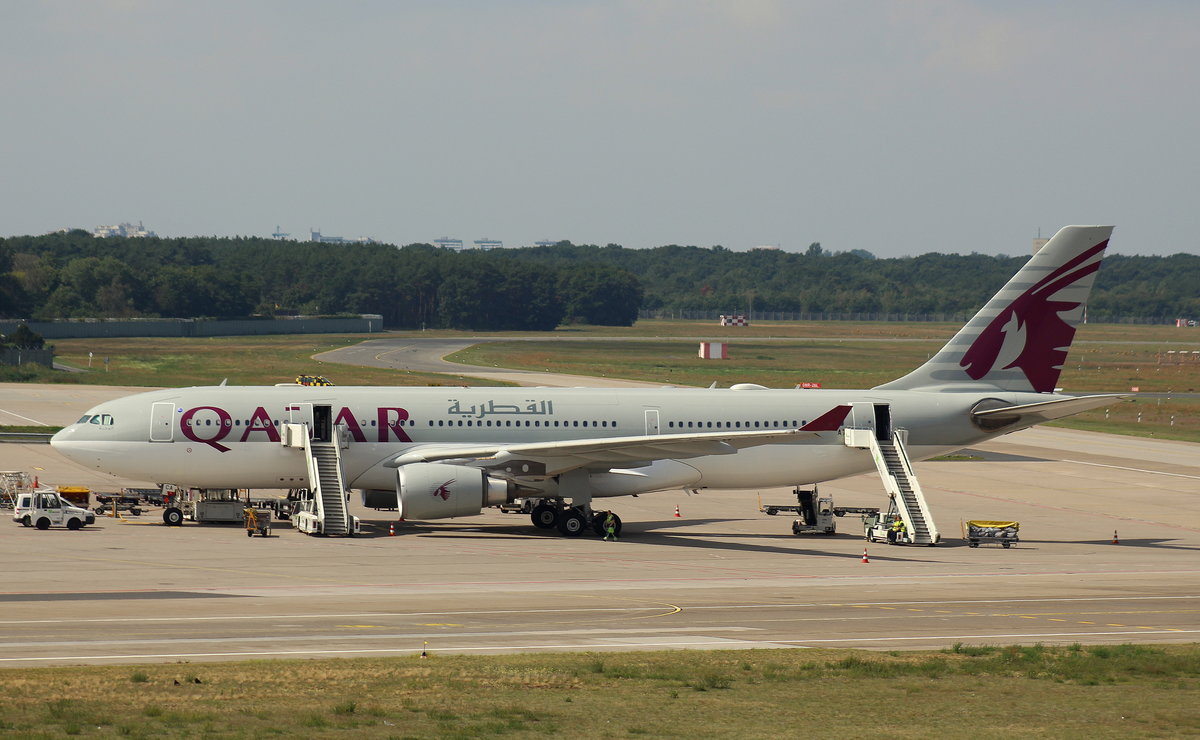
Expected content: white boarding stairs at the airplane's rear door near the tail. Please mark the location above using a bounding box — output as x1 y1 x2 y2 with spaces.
845 428 942 545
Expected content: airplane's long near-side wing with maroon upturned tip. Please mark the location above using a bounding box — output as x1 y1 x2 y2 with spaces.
384 405 850 475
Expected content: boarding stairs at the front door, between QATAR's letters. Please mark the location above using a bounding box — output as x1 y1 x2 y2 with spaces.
281 423 359 537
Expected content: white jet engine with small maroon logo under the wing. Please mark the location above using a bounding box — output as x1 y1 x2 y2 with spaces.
396 463 512 519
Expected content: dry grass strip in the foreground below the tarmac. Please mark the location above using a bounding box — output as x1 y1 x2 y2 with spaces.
0 645 1200 739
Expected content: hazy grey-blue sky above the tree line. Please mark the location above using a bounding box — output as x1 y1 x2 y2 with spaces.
0 0 1200 257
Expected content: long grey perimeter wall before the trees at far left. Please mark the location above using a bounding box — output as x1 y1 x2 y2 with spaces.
0 314 383 339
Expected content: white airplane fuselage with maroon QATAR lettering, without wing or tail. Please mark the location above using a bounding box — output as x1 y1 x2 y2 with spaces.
53 385 1046 497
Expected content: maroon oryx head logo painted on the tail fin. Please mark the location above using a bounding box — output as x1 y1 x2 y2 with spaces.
959 239 1109 393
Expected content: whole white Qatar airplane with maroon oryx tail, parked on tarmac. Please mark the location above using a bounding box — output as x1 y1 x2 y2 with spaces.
50 225 1121 536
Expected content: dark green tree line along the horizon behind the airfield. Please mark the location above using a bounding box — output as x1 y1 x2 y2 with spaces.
0 230 1200 331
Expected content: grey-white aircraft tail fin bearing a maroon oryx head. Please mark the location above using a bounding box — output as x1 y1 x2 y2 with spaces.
878 227 1112 393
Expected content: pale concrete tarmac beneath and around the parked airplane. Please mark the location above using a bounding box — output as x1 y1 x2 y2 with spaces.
0 359 1200 666
